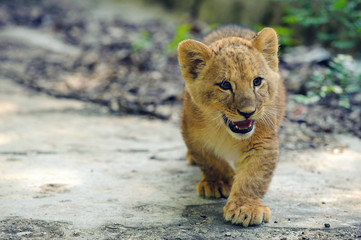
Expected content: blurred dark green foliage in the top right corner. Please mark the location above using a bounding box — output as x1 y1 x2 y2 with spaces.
276 0 361 50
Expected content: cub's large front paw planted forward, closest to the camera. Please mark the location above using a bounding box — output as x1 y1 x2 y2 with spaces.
223 199 271 227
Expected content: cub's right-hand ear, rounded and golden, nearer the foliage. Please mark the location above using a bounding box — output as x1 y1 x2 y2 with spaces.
252 28 278 71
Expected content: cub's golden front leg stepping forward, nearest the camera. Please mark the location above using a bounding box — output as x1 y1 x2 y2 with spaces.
223 140 279 227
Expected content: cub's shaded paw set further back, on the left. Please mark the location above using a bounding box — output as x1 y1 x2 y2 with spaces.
197 180 232 198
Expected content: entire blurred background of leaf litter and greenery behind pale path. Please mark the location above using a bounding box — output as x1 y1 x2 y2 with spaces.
0 0 361 145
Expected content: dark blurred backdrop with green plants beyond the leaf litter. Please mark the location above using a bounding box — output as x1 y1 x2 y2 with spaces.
147 0 361 55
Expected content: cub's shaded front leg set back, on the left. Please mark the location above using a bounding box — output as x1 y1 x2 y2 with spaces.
187 150 234 198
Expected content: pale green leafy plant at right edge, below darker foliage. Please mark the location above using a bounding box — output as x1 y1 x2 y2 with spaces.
294 54 361 108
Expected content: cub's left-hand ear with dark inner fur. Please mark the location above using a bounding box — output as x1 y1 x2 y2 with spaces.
178 40 212 80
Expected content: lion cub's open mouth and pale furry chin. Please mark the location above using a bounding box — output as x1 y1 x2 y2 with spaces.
223 115 255 140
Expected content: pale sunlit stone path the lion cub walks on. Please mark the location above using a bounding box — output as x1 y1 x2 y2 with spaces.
0 79 361 239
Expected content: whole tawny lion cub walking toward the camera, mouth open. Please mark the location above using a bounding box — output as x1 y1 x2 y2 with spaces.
178 25 285 227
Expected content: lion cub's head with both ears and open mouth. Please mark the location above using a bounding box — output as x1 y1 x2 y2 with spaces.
178 28 280 139
